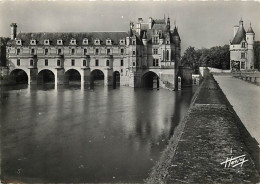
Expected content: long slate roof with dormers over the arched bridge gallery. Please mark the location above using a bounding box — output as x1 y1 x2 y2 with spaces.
8 32 128 46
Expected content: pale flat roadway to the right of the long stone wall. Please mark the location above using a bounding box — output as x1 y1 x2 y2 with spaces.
214 75 260 143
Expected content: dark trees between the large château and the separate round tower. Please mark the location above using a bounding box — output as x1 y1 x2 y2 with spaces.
181 45 230 73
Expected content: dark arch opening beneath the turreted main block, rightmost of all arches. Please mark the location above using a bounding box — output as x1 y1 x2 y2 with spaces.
142 71 160 89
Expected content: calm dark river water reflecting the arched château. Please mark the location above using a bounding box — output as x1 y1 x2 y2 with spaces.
0 86 193 183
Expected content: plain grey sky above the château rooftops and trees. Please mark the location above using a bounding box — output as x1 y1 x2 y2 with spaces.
0 0 260 53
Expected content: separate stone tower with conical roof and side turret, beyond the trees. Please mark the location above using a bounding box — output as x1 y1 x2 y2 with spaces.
229 19 255 71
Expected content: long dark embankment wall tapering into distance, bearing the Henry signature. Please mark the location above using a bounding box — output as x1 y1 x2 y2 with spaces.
146 69 259 183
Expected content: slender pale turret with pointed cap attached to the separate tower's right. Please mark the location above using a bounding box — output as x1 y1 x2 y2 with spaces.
246 23 255 69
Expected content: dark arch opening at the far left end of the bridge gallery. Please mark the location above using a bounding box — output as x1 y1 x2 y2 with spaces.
10 68 29 84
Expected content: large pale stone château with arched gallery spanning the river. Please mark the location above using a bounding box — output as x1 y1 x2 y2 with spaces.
7 17 181 89
